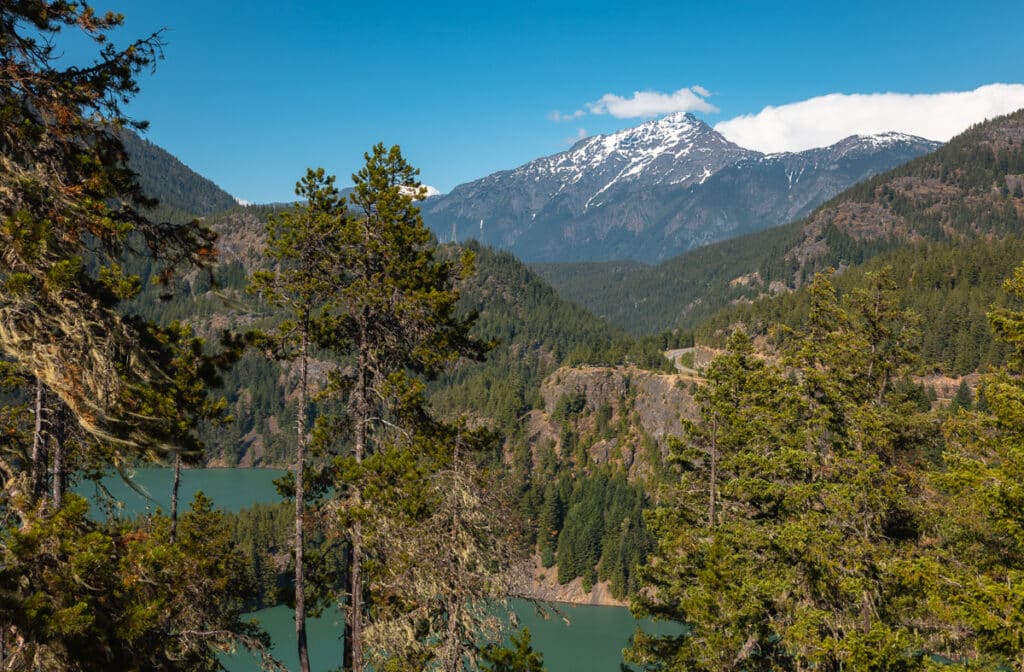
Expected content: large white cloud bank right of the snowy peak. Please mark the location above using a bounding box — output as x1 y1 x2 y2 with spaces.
716 84 1024 152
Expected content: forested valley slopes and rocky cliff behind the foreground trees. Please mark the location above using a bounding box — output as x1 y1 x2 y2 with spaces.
110 109 1024 667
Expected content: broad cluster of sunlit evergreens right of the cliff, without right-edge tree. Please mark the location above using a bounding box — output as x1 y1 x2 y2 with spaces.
630 276 938 670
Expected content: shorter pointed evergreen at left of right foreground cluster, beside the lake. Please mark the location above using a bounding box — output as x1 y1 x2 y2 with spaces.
631 332 808 670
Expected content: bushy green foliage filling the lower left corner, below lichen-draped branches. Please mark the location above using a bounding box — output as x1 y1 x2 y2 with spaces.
0 494 268 671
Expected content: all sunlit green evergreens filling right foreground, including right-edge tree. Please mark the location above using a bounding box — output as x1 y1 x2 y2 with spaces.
630 268 1024 671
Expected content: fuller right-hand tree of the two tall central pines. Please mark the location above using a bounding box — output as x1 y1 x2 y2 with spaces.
311 144 486 670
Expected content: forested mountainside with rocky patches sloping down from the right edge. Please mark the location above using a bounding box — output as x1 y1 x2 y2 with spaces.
535 110 1024 373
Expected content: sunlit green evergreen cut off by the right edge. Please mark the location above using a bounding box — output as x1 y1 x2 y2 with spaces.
928 267 1024 669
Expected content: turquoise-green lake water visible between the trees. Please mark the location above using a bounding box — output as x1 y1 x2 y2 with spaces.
83 467 678 672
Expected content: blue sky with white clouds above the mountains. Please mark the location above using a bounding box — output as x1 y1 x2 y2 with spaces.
75 0 1024 203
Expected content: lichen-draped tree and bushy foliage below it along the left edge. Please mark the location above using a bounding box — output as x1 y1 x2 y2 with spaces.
0 5 266 671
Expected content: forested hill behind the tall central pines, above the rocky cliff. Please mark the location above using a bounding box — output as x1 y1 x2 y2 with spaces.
119 200 679 465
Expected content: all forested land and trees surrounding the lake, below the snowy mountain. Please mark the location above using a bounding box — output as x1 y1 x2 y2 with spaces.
6 0 1024 672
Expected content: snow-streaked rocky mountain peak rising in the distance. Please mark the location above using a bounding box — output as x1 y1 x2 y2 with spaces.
423 114 939 262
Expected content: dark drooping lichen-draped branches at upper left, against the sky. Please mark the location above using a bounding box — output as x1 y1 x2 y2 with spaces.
0 0 213 449
